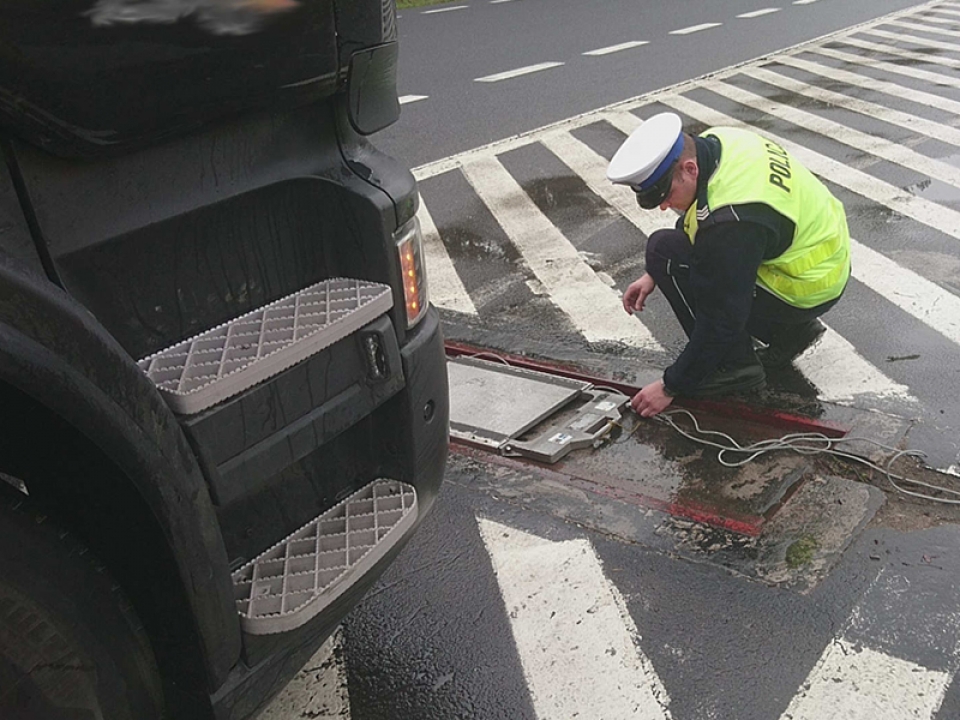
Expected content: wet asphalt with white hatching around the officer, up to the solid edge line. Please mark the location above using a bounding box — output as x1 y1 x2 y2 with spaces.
264 1 960 720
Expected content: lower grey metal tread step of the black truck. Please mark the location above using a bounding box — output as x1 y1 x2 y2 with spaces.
232 479 417 635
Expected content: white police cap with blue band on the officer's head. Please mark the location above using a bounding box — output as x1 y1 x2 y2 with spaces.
607 113 683 190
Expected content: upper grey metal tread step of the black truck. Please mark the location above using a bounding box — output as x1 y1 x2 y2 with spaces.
137 278 393 415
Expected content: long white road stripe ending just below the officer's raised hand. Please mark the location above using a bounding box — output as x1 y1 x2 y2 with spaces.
462 157 662 350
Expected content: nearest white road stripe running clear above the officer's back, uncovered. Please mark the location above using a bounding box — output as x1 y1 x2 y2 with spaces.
710 82 960 188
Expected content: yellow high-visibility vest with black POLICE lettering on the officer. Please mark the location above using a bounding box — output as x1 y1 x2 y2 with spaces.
684 128 850 308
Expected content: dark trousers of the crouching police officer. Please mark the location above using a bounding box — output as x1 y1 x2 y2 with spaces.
646 230 839 362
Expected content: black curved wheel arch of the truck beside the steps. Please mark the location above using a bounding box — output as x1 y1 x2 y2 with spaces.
0 253 240 716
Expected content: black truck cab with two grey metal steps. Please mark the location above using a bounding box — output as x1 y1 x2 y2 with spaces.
0 0 448 720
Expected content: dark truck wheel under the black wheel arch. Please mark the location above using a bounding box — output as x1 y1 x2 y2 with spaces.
0 480 163 720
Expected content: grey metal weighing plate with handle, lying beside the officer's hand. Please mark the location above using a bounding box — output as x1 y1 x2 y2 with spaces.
447 357 628 462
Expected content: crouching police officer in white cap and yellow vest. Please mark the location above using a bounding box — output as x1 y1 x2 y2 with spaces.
607 113 850 417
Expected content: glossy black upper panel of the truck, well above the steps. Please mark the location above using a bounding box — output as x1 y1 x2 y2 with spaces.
0 0 339 156
